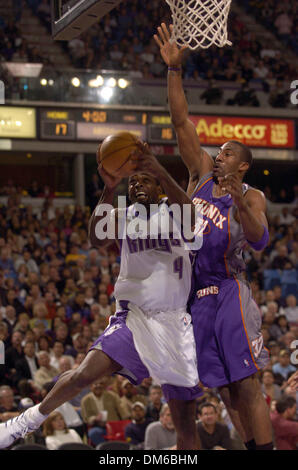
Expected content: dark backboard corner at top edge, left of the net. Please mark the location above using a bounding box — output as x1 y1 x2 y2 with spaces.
51 0 122 41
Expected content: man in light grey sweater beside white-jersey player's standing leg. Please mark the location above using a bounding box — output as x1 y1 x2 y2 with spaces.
144 403 177 450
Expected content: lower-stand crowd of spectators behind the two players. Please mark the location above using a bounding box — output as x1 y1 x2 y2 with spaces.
0 174 298 449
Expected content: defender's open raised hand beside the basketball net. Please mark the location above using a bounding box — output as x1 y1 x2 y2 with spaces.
153 23 187 67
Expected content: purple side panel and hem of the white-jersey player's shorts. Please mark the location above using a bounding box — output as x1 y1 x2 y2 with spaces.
90 301 202 401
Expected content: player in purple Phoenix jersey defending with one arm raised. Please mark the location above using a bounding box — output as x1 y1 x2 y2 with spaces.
154 23 273 450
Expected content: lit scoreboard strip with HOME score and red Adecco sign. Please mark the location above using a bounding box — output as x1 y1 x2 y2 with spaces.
0 106 296 148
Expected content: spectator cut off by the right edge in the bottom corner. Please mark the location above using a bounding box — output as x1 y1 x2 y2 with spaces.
271 396 298 450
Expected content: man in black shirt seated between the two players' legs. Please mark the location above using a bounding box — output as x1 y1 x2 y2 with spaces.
197 402 233 450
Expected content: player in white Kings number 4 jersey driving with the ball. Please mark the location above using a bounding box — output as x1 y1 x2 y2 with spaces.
0 143 201 449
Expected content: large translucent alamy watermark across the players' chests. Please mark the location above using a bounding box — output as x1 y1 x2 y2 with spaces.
95 196 203 250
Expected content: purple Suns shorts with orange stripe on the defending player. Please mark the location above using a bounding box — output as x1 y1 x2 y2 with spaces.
190 279 269 388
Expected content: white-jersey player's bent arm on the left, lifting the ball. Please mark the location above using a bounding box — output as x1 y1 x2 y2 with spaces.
88 152 122 247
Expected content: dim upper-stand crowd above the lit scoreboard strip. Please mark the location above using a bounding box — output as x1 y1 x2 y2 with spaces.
0 0 298 107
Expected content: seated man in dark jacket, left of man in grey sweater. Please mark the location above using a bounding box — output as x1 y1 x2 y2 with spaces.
124 401 153 449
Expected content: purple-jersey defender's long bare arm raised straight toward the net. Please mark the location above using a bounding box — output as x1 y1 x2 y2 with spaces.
154 23 213 193
